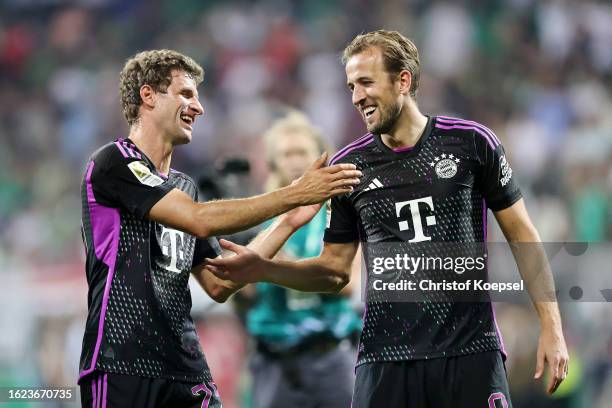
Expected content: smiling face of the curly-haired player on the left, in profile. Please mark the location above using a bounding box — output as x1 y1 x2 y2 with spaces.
152 70 204 145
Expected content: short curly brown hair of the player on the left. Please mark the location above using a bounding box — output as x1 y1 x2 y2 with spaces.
119 50 204 126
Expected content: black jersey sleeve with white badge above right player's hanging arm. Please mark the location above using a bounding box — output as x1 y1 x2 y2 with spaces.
477 135 522 211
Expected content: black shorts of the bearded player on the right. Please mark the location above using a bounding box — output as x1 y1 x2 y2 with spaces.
351 351 512 408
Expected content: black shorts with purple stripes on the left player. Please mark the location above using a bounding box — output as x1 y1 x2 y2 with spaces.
81 371 222 408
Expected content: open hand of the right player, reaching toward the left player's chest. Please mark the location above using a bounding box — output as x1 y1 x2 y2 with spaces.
206 239 264 285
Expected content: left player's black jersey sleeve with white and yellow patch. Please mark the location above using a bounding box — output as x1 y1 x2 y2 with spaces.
91 145 174 218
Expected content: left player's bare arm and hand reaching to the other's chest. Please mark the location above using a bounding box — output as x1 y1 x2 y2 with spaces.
148 153 361 238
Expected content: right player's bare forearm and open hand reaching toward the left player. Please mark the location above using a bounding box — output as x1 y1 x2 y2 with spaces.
207 240 358 292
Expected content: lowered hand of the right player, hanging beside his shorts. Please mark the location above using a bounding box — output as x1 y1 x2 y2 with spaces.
534 329 569 395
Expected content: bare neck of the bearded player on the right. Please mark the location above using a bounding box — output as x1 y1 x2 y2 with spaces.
381 101 427 149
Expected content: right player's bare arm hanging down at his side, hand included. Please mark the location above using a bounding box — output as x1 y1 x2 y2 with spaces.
495 199 569 394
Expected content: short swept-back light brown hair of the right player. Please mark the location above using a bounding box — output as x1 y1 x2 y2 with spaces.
342 30 421 98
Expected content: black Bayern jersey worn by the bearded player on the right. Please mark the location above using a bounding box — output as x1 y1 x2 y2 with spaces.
324 116 521 364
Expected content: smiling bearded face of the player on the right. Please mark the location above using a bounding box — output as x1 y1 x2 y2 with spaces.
345 47 403 134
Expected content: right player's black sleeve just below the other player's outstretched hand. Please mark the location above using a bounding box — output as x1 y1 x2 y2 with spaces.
323 194 359 243
